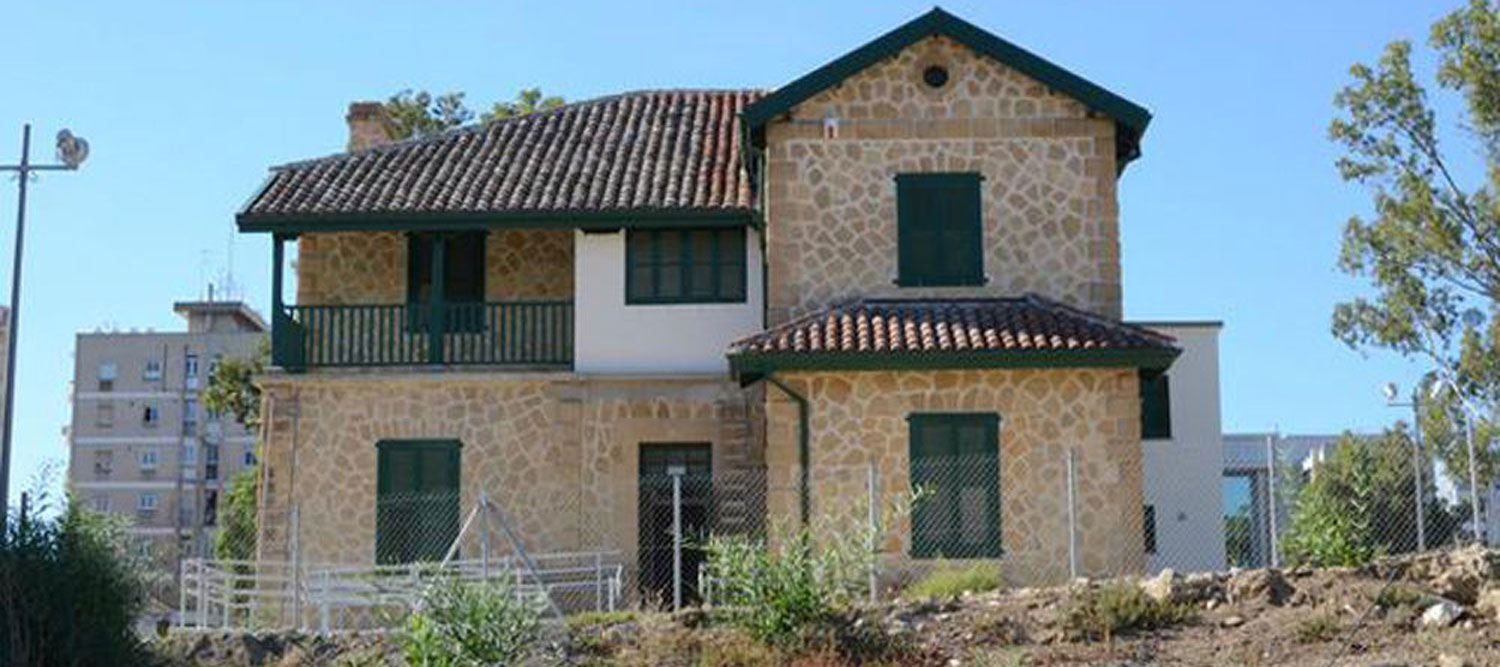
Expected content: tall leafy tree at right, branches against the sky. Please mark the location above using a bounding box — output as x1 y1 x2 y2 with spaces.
1329 0 1500 486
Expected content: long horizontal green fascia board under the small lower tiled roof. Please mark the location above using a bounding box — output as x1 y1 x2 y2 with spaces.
729 348 1182 376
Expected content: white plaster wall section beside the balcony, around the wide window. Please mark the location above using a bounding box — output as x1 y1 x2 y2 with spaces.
573 229 765 375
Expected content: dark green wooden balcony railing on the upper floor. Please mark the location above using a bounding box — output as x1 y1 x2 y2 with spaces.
272 301 573 370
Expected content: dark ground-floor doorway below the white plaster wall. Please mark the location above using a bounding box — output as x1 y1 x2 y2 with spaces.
638 442 714 606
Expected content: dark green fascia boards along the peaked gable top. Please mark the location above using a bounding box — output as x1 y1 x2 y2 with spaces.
741 7 1151 169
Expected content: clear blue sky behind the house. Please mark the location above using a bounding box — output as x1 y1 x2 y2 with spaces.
0 0 1457 497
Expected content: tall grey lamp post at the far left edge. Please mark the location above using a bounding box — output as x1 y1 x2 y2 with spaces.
0 123 89 513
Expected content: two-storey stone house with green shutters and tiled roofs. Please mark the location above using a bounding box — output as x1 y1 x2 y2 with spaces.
237 9 1179 593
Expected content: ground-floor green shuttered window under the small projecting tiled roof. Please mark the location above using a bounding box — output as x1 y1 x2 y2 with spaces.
908 412 1004 559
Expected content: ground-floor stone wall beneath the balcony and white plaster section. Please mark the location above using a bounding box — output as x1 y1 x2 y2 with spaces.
261 373 762 568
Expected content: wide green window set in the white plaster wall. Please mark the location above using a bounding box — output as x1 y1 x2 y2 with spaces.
626 226 747 304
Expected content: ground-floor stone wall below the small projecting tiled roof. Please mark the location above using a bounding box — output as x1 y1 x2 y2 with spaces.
767 369 1145 583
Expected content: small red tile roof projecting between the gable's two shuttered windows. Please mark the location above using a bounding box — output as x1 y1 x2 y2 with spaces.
729 295 1178 368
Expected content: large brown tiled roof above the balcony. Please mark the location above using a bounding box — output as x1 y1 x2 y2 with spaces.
240 90 762 225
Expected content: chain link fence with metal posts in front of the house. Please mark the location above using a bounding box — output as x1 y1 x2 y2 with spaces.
158 438 1478 631
